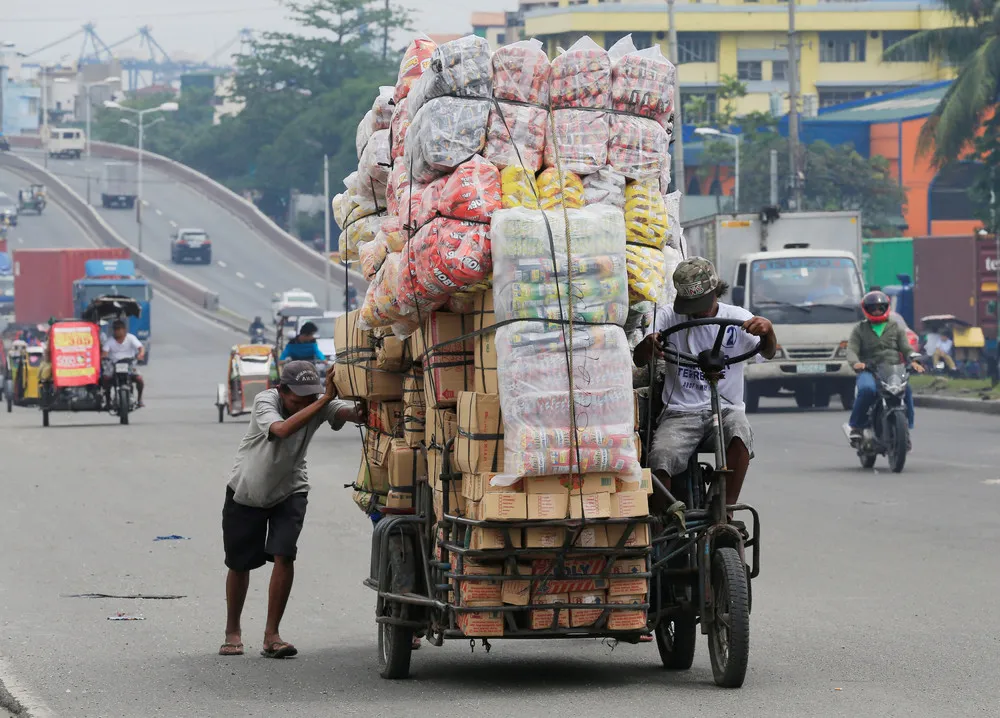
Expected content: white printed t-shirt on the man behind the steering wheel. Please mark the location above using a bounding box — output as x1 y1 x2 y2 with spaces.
646 302 761 411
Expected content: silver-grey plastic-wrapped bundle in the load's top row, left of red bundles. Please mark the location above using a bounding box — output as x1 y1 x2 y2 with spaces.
409 35 493 115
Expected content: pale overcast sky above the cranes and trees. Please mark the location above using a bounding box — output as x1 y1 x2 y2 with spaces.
0 0 517 62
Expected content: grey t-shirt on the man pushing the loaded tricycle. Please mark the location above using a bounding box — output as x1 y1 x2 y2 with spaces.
229 389 352 508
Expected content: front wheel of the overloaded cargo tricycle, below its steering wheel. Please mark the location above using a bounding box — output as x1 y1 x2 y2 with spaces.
708 546 750 688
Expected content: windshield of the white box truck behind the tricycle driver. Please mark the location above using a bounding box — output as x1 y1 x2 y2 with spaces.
750 257 861 324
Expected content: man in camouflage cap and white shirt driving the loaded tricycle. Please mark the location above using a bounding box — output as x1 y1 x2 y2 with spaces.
634 257 778 503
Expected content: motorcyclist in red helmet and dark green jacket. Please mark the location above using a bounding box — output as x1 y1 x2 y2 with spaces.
847 291 924 443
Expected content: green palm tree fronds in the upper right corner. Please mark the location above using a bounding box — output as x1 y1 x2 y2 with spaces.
886 0 1000 166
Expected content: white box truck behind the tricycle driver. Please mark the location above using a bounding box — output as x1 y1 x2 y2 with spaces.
684 211 864 412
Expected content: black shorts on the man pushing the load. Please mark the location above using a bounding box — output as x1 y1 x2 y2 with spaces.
222 486 309 571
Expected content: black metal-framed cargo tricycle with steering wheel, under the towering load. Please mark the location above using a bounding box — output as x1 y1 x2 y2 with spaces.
365 319 760 687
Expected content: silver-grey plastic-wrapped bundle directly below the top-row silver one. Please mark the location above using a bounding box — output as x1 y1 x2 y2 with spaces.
403 97 490 184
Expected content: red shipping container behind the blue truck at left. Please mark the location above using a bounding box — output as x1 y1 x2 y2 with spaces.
13 248 131 324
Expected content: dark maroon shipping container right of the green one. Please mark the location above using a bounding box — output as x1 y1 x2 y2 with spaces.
913 235 997 338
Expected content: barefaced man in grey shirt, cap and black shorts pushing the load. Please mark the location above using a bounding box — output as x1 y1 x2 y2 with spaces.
219 361 364 658
